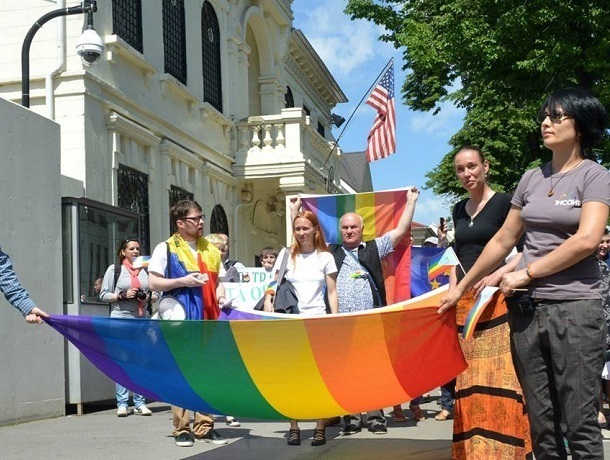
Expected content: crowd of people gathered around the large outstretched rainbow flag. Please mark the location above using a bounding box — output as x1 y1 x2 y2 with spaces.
0 88 610 460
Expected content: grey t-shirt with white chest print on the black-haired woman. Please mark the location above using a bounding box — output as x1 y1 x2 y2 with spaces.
512 160 610 300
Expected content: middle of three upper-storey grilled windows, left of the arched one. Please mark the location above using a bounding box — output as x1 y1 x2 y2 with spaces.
163 0 186 85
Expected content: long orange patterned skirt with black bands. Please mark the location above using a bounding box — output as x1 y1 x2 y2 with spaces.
451 292 532 460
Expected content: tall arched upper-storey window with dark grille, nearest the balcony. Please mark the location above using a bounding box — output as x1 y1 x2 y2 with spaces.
201 2 222 112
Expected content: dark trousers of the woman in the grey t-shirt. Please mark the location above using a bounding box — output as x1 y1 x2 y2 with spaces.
508 299 606 460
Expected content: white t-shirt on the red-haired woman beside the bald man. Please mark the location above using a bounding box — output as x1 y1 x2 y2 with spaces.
274 249 337 315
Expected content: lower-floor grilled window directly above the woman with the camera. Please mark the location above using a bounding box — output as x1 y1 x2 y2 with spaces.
117 164 150 254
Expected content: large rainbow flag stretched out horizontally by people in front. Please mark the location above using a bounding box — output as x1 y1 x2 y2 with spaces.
48 287 466 419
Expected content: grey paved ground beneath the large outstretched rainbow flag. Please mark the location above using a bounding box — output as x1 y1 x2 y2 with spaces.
0 401 610 460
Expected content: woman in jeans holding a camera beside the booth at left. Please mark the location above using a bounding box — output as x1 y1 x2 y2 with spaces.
100 238 157 417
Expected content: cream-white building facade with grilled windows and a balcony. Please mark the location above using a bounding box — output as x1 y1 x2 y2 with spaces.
0 0 346 418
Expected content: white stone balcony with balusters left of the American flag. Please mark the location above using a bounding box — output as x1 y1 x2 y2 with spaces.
234 108 341 189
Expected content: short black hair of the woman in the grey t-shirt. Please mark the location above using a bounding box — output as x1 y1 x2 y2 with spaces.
540 88 608 157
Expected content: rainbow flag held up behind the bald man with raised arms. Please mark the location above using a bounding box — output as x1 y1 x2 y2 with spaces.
302 190 411 304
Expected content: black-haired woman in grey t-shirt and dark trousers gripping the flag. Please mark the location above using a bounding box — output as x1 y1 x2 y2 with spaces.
439 88 610 459
